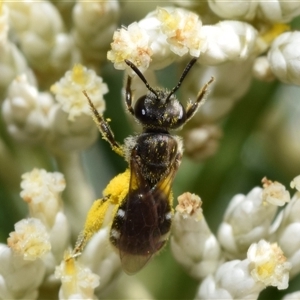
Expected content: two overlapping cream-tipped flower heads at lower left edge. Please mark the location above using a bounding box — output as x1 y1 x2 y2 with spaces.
0 169 70 299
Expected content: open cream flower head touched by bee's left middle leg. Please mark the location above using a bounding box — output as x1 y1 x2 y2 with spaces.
51 65 108 121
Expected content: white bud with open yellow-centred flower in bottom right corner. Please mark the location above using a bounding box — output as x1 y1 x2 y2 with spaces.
196 240 290 299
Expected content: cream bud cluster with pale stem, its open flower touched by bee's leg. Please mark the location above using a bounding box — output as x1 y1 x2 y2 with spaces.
1 64 108 252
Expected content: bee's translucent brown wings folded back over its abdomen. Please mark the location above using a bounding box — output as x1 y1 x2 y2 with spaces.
119 159 177 275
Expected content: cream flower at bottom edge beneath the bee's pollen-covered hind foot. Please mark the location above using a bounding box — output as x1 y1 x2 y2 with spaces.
55 253 100 299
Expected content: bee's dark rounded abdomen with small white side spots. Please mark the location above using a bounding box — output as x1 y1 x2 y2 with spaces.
110 191 172 255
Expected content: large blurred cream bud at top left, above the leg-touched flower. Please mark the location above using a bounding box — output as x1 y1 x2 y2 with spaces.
7 1 74 74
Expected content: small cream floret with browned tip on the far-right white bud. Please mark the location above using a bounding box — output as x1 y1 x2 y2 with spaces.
262 177 290 206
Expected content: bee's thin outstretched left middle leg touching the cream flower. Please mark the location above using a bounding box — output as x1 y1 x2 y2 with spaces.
83 91 124 156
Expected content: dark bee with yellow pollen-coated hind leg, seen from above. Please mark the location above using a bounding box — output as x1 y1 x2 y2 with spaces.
74 58 214 275
